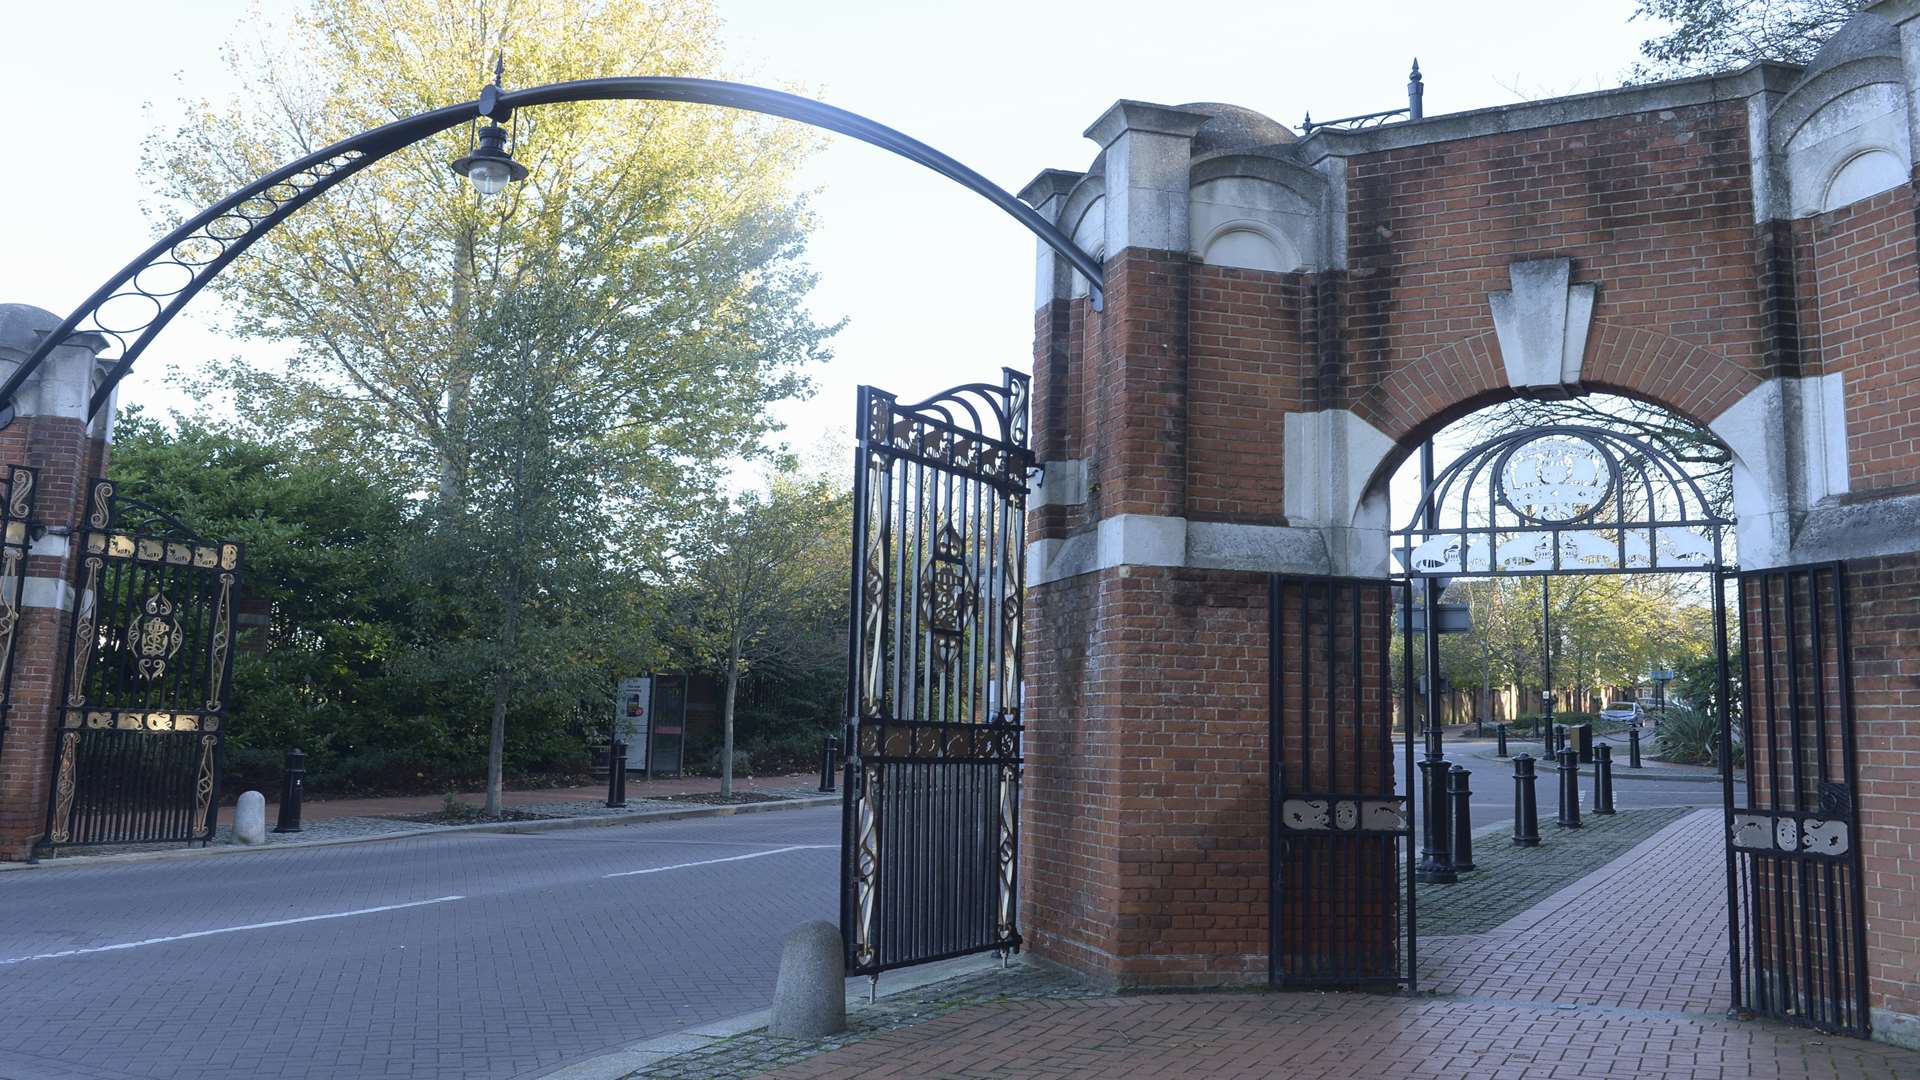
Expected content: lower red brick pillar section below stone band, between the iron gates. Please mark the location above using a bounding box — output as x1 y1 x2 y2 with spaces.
1021 567 1267 986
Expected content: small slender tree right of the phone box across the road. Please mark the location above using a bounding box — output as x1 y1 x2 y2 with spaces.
682 479 852 796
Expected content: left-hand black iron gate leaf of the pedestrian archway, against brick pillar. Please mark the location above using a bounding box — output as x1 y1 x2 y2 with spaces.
1267 575 1413 988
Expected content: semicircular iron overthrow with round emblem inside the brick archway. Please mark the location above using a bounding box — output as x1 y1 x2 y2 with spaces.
1392 425 1732 577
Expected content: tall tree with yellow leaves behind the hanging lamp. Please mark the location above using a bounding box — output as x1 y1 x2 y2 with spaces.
146 0 829 509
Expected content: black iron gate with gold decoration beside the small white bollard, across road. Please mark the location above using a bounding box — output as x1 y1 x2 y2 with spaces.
46 480 242 847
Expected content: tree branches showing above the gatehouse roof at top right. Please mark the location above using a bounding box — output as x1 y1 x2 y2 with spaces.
1632 0 1872 81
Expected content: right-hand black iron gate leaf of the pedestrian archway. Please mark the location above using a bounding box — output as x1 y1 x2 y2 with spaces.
1720 563 1868 1036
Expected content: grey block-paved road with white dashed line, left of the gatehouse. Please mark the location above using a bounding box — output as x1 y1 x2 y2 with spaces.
0 807 839 1080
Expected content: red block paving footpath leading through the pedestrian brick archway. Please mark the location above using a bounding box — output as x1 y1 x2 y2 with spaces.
737 811 1920 1080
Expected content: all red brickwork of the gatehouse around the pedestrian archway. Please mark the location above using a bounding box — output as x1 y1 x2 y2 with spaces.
1023 94 1920 1013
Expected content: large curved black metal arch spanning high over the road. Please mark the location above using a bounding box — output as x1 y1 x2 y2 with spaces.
0 75 1106 427
